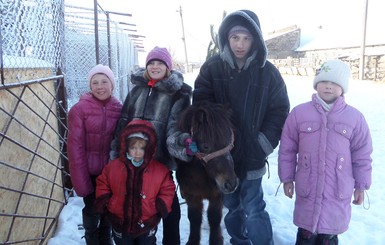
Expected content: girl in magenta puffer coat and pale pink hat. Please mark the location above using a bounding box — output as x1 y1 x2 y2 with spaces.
67 64 122 245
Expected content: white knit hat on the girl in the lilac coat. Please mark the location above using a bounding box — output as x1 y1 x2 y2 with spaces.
313 60 351 93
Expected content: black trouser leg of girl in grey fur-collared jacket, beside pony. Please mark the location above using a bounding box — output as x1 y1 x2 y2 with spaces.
162 190 180 245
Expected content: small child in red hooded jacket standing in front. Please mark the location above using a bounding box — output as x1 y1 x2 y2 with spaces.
95 120 175 245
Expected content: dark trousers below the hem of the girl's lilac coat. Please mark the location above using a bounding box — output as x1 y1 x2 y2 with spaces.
295 228 338 245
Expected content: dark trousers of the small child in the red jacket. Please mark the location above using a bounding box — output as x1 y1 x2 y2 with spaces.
112 227 157 245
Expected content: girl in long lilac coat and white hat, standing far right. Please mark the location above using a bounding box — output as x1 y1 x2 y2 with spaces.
278 60 372 244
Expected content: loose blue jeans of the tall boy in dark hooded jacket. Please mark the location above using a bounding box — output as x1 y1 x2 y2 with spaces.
224 178 274 245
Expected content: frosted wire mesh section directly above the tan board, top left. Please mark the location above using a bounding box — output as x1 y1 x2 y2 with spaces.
0 0 63 82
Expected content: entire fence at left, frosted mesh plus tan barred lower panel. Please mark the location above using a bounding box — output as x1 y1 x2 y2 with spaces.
0 0 137 244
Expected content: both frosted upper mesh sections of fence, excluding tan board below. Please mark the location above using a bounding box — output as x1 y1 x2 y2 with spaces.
0 0 138 108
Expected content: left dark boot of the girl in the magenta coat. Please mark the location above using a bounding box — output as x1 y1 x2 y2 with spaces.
82 209 100 245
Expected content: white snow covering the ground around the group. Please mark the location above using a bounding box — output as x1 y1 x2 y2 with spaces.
48 73 385 245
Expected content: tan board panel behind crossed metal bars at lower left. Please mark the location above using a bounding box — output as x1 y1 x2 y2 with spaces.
0 75 66 244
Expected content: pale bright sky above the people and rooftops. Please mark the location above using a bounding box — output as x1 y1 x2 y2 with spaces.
65 0 385 65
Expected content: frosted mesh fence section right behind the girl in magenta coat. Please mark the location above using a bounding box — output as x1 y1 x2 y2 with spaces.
64 5 138 108
